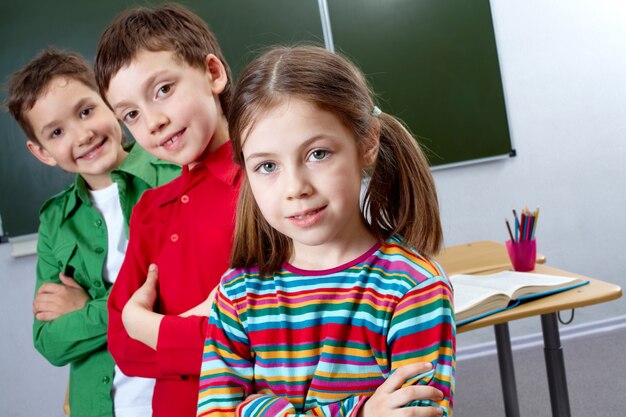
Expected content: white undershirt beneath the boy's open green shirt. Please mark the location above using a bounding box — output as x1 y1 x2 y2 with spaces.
89 183 154 417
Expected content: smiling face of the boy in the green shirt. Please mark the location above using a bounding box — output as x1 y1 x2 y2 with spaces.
26 77 126 189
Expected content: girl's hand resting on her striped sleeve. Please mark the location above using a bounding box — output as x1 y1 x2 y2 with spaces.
358 362 443 417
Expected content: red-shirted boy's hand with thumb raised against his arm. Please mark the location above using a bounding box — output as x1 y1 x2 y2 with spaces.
122 264 163 349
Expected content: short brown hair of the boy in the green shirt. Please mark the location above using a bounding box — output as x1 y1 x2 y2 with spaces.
5 48 98 143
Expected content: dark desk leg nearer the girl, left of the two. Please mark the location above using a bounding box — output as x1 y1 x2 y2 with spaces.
494 323 520 417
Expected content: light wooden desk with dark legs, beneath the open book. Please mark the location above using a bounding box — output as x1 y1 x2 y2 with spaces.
437 241 622 417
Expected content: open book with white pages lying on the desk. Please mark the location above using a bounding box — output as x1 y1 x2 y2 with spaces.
450 271 589 325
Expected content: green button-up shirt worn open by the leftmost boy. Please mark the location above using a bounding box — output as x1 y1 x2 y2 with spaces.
33 141 180 417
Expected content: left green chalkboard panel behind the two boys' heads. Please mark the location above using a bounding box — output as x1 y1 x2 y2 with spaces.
0 0 323 238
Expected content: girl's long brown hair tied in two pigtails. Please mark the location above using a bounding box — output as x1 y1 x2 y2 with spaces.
228 46 443 274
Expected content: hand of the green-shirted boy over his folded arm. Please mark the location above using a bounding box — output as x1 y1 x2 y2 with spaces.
33 274 89 321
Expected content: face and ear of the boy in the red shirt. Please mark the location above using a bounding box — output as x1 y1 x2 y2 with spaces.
106 50 228 165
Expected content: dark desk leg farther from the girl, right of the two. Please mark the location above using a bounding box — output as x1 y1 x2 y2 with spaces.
541 313 571 417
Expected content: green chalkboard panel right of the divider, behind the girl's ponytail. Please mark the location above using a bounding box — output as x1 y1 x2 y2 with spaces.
328 0 512 166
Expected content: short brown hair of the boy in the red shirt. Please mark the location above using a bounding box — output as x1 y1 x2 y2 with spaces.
94 4 232 117
